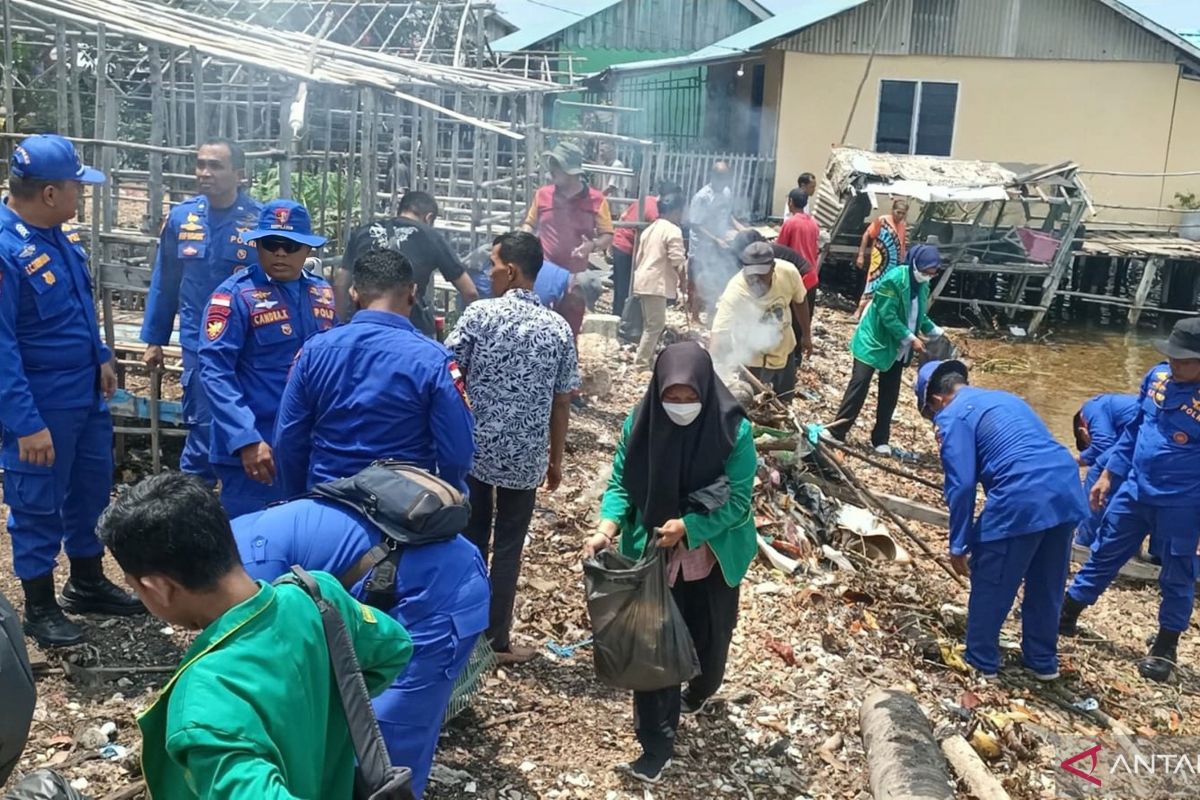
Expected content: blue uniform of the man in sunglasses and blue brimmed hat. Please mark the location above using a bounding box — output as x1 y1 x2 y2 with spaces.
199 263 335 517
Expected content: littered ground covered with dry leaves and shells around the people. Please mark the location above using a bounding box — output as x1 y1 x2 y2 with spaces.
0 307 1200 800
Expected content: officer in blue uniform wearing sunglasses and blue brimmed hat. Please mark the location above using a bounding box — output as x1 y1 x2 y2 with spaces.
199 200 335 517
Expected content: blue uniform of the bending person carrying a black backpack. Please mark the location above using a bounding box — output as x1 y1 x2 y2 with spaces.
233 499 491 798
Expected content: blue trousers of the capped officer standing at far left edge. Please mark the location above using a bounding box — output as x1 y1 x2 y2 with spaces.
0 396 113 581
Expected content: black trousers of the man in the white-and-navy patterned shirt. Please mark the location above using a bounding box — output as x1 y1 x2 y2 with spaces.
463 476 538 652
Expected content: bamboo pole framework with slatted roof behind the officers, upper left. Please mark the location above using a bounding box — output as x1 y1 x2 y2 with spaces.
0 0 563 469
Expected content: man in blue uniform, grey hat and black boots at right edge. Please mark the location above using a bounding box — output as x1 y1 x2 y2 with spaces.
1060 318 1200 682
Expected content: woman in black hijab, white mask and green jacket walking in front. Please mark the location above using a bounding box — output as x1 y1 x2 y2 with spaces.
584 342 758 783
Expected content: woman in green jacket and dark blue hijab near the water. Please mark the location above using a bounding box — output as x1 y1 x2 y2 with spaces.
829 245 942 455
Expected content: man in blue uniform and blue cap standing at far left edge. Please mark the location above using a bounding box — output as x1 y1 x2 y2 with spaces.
0 134 145 646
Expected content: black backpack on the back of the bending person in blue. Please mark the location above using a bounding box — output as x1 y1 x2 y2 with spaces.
307 461 470 612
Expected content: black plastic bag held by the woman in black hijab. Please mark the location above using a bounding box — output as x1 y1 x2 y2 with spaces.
583 543 700 692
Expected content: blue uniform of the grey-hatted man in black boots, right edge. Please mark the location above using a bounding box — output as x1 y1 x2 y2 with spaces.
1068 361 1200 632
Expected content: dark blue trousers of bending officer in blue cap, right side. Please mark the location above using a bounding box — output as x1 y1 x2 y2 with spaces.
965 524 1075 674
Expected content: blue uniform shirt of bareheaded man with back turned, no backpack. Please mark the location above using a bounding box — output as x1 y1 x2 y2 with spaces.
275 311 475 498
